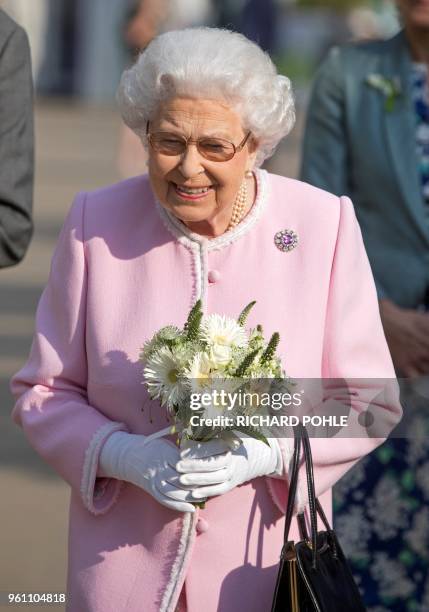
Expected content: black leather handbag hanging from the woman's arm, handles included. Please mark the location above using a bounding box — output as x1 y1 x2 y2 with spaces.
271 425 366 612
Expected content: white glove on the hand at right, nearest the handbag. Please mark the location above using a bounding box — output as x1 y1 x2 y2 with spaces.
176 434 283 500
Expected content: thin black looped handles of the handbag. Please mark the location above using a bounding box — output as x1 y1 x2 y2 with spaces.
283 424 337 569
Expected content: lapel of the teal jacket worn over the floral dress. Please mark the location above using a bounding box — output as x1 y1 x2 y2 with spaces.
382 32 427 239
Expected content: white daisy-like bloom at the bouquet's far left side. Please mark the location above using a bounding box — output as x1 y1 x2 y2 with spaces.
143 346 187 410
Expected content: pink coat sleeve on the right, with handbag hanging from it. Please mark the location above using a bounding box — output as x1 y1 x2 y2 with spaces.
268 197 402 512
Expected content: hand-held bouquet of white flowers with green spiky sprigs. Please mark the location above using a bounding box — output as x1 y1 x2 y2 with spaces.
140 300 286 446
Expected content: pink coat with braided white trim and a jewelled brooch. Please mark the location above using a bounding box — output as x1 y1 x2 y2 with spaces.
12 171 400 612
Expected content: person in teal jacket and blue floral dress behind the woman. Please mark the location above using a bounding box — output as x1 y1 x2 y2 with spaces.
301 0 429 612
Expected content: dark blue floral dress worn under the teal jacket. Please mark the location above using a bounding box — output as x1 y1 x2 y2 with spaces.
334 64 429 612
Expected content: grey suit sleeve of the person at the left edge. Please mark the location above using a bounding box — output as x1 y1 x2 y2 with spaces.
0 26 34 268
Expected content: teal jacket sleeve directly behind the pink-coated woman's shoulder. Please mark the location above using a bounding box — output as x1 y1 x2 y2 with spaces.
301 47 351 196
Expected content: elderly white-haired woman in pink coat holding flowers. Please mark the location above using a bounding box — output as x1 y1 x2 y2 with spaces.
12 28 400 612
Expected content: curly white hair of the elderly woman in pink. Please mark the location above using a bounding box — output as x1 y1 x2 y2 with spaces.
117 27 295 166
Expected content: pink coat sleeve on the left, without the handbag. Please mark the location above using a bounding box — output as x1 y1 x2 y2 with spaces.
11 194 126 514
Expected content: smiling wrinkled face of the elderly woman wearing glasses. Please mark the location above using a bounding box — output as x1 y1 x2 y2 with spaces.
148 97 256 223
